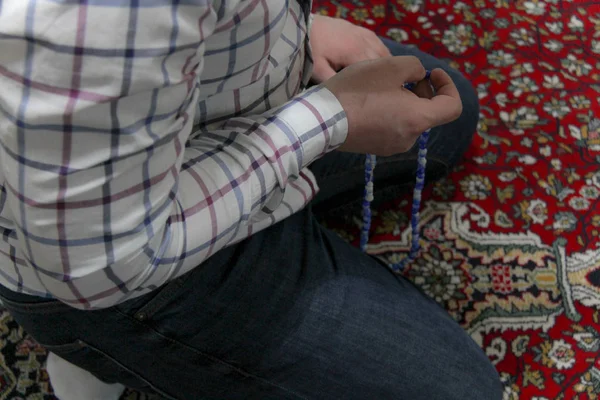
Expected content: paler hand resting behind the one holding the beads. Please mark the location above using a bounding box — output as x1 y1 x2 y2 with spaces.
310 15 390 83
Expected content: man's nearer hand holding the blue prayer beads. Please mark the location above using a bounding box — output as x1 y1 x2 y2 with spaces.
324 56 462 156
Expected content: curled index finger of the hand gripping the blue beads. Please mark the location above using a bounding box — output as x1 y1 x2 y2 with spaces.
415 69 462 128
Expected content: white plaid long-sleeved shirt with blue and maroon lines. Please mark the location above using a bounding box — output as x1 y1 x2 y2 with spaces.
0 0 347 309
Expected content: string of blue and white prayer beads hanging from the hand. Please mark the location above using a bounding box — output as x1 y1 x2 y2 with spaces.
360 71 431 271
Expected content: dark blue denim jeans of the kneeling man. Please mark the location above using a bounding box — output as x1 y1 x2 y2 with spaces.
0 42 502 400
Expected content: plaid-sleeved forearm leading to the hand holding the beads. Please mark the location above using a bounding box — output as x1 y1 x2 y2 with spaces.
169 88 347 267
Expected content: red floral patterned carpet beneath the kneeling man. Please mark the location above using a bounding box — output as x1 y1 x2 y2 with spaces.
0 0 600 400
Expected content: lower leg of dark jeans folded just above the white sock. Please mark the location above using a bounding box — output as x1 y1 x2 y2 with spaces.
41 340 171 399
